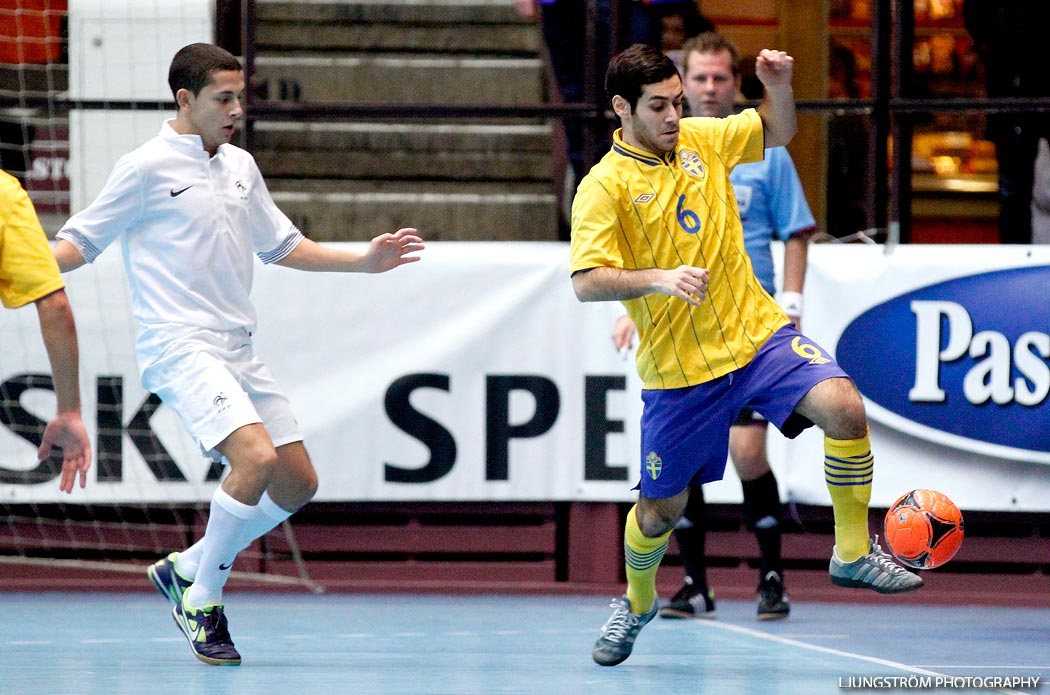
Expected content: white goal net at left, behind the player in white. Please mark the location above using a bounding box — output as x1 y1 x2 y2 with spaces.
0 0 318 590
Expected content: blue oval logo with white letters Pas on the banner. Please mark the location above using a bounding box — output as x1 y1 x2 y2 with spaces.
836 266 1050 460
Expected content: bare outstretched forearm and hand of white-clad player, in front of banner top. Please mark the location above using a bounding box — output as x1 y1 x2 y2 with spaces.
277 228 423 273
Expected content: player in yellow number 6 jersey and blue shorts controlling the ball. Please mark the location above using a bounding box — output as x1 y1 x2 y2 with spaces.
570 44 922 666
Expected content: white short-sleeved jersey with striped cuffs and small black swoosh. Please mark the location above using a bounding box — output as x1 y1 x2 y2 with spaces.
58 122 303 361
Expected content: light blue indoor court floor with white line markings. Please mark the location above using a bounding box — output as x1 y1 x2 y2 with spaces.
0 592 1050 695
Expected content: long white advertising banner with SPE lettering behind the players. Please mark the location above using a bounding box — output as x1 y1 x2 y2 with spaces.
0 243 1050 511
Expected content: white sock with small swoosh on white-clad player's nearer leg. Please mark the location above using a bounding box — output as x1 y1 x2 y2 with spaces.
183 487 257 608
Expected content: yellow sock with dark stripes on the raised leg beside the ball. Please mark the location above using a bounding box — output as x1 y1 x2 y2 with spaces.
824 434 874 563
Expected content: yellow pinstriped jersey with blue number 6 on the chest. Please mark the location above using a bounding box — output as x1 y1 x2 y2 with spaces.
570 109 789 388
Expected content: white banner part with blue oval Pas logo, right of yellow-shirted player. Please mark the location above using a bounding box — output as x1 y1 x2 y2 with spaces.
760 245 1050 511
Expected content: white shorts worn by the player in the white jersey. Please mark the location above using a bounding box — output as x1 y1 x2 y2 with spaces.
142 329 302 461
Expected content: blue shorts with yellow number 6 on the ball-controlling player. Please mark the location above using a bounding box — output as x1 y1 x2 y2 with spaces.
641 324 849 499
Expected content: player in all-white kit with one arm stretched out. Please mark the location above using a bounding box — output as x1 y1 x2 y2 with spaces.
55 43 423 666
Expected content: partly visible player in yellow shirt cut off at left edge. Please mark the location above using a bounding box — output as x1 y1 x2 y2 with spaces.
0 171 91 492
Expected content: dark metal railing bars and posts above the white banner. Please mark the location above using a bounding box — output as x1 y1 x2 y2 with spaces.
8 0 1050 241
